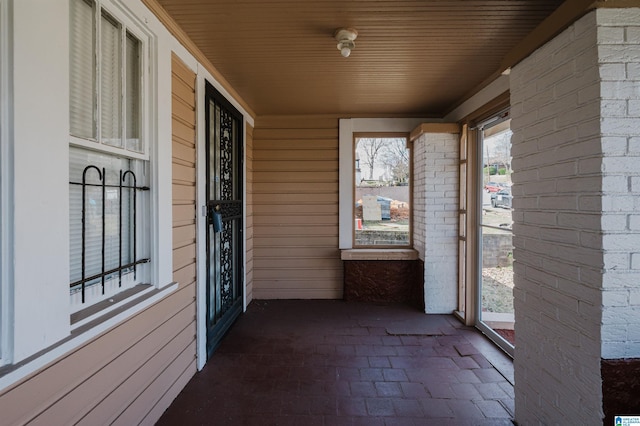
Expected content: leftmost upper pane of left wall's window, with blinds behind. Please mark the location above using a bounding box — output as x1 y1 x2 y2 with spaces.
69 0 96 139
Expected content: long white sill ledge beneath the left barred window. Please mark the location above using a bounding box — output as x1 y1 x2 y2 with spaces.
0 282 178 390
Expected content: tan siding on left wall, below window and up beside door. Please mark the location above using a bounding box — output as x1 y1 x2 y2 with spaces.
0 58 196 425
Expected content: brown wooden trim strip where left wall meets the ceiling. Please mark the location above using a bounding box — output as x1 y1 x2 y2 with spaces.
142 0 256 119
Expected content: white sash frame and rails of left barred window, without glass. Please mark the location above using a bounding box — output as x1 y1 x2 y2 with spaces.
69 0 158 322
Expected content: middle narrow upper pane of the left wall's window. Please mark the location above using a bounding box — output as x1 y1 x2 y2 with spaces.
100 12 122 146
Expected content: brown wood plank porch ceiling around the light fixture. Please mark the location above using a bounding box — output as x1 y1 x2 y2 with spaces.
157 0 562 116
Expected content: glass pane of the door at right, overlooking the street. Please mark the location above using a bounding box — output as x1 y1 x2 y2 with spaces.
477 111 515 356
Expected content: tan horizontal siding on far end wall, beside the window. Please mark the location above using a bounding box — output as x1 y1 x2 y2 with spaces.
251 116 342 299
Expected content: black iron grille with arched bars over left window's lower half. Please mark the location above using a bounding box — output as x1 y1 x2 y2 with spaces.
69 165 150 303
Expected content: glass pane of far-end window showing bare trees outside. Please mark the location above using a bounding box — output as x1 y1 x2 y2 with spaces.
354 137 411 247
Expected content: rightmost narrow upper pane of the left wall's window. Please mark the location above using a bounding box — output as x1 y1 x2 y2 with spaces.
125 32 143 152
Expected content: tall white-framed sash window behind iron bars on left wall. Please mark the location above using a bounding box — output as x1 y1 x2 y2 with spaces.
69 0 151 312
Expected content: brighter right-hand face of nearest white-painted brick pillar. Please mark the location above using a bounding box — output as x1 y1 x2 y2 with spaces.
597 9 640 359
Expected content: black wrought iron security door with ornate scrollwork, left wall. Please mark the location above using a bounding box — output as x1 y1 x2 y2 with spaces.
205 83 244 357
